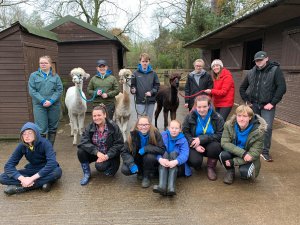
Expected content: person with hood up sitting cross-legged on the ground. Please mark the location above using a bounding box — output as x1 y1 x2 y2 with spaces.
0 122 62 195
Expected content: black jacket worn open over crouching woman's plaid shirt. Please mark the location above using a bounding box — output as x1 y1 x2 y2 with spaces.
78 119 124 159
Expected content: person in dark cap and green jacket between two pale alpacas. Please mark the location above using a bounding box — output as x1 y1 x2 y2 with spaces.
87 59 120 120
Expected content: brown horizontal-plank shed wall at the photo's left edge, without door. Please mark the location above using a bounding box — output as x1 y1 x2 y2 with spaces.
0 31 29 137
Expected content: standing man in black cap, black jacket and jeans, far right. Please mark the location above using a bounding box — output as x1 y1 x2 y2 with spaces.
240 51 286 162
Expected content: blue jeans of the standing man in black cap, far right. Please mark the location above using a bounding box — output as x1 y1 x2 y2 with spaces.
252 103 276 155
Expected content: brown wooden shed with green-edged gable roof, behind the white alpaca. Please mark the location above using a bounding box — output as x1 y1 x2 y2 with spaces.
46 16 128 88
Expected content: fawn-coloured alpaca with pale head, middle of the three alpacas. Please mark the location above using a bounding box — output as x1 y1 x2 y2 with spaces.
114 69 132 141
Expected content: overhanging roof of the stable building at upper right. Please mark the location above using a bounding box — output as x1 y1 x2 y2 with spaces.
183 0 300 48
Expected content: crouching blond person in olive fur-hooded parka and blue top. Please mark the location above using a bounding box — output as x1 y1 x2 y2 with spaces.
220 105 267 184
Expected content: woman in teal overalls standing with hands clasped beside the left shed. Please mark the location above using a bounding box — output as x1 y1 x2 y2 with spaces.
28 56 63 145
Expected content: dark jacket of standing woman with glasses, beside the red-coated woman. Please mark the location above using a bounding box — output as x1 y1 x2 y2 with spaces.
184 71 214 109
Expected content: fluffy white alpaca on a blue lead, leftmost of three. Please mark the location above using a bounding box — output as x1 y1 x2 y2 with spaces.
65 67 90 145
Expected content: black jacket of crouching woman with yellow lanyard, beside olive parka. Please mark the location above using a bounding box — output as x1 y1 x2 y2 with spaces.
182 111 224 145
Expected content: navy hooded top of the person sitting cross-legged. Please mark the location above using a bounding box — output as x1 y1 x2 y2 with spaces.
4 122 58 180
